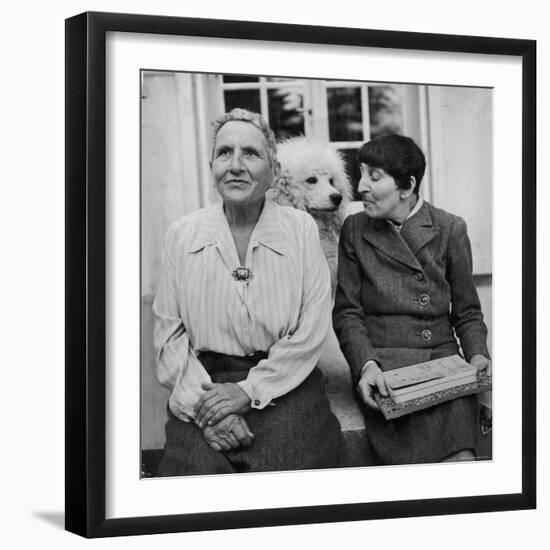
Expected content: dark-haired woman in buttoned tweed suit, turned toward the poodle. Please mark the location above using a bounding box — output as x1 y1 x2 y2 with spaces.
333 136 491 464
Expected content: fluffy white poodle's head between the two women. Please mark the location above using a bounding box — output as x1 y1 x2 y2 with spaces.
271 136 351 216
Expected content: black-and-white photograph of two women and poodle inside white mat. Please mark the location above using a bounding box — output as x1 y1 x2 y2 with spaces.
141 69 498 478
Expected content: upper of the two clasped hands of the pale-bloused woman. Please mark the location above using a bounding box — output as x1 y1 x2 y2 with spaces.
195 383 250 428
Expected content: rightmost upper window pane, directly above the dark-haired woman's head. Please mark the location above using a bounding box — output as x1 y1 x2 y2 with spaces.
369 85 403 138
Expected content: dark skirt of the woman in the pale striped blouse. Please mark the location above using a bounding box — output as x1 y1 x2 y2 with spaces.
157 352 341 476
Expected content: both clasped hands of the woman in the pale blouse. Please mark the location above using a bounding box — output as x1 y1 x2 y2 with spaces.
195 383 254 452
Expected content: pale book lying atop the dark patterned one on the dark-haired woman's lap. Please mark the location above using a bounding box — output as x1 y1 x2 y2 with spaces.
384 355 477 403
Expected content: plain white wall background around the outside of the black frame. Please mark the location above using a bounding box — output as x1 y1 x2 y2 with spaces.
0 0 550 550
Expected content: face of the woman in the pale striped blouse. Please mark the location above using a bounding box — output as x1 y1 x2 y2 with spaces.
211 120 274 206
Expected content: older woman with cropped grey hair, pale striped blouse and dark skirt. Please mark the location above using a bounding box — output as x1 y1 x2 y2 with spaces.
153 109 340 476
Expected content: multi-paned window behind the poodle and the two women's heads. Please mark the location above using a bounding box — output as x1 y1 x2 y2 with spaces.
218 75 419 198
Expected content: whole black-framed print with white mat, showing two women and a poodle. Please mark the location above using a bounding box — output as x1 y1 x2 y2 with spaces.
66 13 536 537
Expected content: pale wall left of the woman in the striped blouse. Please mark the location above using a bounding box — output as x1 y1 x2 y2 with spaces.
141 72 218 297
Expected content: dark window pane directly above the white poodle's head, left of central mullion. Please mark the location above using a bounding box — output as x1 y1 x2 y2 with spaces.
267 88 304 139
